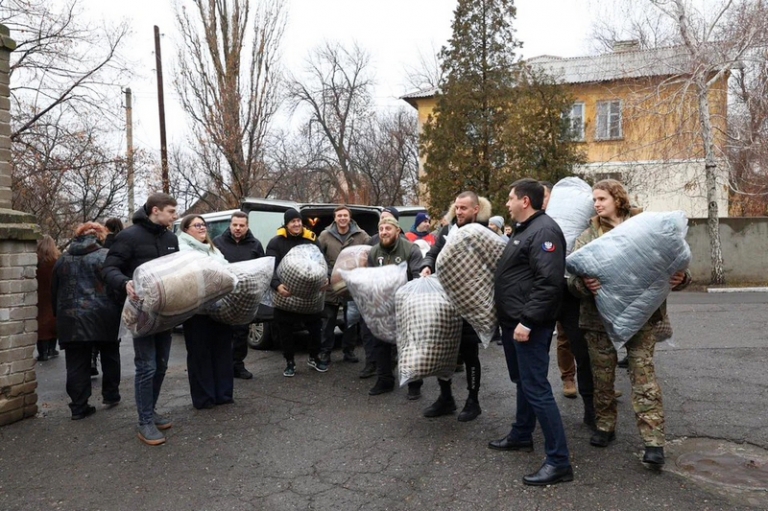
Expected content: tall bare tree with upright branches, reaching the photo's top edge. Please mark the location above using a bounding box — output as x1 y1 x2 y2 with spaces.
174 0 285 207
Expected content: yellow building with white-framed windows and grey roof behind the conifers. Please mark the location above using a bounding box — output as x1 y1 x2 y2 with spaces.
402 42 728 217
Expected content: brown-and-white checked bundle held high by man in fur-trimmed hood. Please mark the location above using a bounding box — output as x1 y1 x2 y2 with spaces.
436 224 506 347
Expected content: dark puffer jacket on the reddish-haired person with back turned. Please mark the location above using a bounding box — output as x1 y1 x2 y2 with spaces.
51 235 121 346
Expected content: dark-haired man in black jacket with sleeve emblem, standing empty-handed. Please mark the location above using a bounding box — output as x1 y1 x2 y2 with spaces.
488 179 573 486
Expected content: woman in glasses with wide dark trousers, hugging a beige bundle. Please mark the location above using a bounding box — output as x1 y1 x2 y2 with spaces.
179 215 235 410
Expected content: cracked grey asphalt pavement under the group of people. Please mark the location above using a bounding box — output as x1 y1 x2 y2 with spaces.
0 293 768 511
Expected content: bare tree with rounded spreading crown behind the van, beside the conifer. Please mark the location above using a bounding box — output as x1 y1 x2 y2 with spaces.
288 43 373 203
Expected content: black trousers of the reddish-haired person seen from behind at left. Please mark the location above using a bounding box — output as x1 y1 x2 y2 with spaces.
64 341 120 414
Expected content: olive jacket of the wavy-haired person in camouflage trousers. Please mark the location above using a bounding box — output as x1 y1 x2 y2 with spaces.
568 208 691 332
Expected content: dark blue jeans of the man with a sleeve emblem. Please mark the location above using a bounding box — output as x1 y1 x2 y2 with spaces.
501 325 571 468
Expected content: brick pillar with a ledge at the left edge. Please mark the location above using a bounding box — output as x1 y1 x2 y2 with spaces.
0 25 40 426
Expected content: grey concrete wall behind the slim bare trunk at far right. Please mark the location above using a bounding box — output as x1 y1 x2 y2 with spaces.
688 217 768 284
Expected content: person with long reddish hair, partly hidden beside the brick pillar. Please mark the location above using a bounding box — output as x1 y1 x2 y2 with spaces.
37 234 61 362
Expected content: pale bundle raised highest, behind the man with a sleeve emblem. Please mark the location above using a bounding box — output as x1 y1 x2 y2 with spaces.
547 177 595 255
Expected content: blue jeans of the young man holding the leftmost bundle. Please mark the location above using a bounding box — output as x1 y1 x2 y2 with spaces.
133 330 171 425
